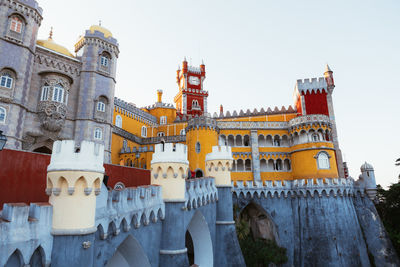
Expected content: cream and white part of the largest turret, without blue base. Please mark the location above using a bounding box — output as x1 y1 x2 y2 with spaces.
46 140 104 235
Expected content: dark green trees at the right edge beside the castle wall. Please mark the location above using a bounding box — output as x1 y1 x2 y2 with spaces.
376 182 400 255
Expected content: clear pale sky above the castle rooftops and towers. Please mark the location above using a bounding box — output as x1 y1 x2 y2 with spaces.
38 0 400 186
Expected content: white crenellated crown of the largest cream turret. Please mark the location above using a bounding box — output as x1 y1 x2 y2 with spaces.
47 140 104 173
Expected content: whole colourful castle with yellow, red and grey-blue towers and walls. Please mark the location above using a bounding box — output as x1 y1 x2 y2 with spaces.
0 0 399 266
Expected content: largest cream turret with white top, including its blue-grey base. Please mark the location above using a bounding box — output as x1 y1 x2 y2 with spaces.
46 140 104 266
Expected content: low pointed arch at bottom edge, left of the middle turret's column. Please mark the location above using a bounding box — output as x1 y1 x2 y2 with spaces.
106 235 151 267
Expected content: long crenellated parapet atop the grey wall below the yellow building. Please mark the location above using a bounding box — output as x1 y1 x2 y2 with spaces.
232 178 364 198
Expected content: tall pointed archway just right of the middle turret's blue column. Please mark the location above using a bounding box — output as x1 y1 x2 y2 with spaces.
185 211 214 266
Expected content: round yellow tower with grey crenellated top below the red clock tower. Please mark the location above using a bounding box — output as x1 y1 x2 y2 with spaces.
186 116 219 177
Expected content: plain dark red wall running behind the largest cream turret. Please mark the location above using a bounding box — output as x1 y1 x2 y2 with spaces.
0 149 150 209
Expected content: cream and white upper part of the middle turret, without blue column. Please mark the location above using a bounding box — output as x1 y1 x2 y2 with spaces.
151 143 189 201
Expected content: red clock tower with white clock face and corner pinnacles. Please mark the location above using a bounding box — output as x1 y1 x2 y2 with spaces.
174 58 208 117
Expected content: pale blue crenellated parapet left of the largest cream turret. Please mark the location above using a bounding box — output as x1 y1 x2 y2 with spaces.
0 203 53 266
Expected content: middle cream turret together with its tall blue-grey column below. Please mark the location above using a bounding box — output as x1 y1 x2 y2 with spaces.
151 143 189 267
